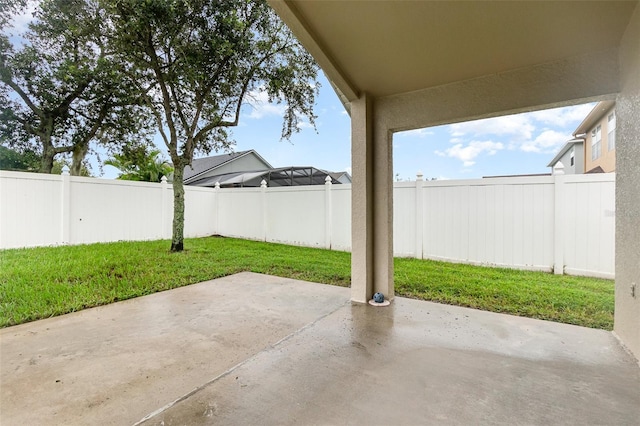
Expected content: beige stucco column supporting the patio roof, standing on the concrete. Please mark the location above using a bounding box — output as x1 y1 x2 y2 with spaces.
351 94 393 303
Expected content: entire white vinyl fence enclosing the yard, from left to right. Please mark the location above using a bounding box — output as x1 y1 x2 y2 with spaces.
0 172 615 278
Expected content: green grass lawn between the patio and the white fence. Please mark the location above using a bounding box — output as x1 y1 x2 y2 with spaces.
0 237 614 330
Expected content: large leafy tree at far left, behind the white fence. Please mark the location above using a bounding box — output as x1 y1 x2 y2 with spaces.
0 0 151 175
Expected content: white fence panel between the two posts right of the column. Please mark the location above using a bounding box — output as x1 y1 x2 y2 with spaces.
422 177 554 270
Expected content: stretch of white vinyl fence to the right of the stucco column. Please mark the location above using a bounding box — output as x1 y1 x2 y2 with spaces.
394 173 615 278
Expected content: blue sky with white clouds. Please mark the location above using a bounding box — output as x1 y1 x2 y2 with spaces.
103 70 595 180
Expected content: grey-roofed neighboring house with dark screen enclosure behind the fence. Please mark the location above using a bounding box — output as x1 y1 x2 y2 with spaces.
184 150 351 188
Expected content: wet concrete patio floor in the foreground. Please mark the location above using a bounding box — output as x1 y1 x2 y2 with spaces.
0 273 640 426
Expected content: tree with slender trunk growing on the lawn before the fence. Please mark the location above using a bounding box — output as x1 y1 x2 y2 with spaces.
111 0 318 251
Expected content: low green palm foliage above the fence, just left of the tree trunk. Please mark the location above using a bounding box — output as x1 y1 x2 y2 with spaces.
104 146 173 182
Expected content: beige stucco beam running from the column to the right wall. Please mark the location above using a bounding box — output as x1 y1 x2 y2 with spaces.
375 49 619 132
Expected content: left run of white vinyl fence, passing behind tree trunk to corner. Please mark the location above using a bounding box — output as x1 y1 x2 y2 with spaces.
0 171 215 248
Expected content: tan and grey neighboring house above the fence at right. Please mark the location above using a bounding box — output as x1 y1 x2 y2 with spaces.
547 101 616 174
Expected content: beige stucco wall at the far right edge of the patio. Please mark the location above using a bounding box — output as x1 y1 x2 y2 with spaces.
614 5 640 360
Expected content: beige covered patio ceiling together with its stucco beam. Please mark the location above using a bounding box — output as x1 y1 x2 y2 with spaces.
268 0 638 126
